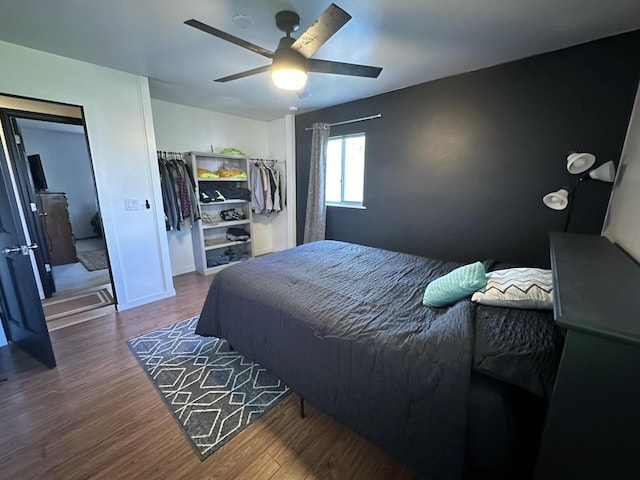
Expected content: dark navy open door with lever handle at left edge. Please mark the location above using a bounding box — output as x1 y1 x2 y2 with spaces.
0 131 56 368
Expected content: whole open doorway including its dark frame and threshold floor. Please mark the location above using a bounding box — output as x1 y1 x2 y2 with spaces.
0 96 115 330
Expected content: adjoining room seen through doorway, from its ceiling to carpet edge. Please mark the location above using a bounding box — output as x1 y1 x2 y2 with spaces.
17 118 110 296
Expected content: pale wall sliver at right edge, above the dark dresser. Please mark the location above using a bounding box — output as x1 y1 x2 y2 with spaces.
603 84 640 262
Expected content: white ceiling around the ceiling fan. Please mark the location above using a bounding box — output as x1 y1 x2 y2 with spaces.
0 0 640 120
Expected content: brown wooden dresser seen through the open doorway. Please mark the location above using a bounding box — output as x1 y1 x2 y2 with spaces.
38 192 78 266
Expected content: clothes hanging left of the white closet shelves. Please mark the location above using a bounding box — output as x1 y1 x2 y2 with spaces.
157 152 200 231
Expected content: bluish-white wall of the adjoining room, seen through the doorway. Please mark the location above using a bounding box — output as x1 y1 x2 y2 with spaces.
18 124 98 239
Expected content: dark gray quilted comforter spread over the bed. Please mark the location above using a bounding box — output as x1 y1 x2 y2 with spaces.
196 241 560 480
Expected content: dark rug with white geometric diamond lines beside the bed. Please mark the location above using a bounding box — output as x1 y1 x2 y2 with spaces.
128 317 289 460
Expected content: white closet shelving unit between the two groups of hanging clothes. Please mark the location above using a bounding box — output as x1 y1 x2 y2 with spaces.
185 152 253 275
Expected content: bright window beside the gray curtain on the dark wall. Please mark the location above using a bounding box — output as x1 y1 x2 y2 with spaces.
325 133 365 207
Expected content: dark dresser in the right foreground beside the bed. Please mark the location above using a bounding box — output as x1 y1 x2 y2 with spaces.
535 233 640 480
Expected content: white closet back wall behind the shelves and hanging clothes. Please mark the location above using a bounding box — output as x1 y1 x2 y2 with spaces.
151 99 295 275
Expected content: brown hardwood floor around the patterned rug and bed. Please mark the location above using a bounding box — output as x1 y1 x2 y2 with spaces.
0 273 420 480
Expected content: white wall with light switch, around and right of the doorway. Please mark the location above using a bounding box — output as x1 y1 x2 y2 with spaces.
0 42 175 310
